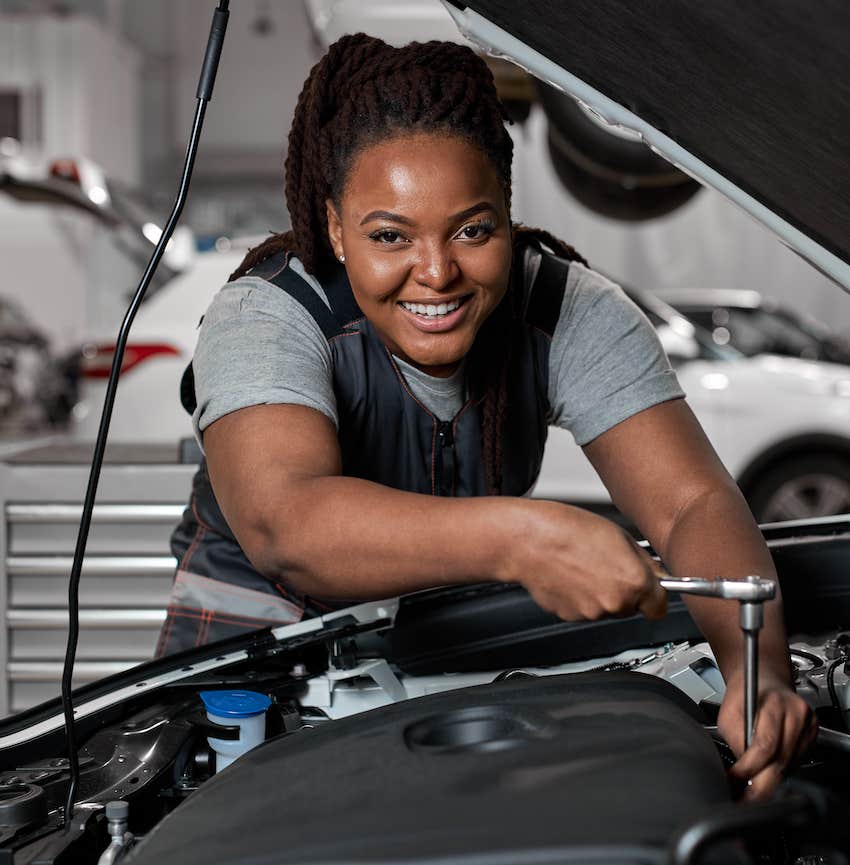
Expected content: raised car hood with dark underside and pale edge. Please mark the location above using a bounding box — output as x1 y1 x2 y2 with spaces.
444 0 850 291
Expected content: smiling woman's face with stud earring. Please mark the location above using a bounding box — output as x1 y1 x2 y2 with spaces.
327 133 511 376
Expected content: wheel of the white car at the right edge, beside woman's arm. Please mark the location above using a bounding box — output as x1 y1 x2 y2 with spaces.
748 456 850 523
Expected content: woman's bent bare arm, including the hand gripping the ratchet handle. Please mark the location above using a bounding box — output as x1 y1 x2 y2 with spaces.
204 405 664 619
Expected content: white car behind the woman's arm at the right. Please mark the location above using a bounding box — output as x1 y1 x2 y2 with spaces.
535 291 850 523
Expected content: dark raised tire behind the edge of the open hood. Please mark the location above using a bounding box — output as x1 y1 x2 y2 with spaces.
538 84 702 221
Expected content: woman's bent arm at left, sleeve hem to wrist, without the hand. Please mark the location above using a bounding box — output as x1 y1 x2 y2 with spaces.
204 405 510 599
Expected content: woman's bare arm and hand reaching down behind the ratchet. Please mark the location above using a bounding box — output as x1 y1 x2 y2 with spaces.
585 400 816 795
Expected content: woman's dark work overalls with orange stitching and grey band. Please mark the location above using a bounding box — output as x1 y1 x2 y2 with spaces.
157 241 568 656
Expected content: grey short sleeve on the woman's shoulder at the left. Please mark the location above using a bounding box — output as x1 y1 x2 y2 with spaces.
192 277 337 441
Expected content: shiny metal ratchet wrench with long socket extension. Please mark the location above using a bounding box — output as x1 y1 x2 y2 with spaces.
659 576 776 748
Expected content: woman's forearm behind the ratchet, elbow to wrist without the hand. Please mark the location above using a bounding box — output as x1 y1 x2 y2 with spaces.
659 487 790 682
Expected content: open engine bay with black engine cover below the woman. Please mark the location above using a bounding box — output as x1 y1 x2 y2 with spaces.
0 524 850 865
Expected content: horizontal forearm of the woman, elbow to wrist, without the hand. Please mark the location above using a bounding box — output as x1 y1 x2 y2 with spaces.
235 476 524 599
